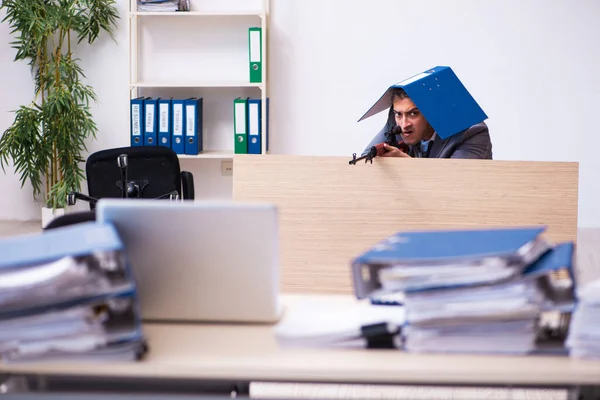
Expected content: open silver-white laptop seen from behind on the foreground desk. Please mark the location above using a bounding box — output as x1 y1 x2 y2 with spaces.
96 199 280 323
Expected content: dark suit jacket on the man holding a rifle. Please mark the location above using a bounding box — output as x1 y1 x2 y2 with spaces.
363 108 492 160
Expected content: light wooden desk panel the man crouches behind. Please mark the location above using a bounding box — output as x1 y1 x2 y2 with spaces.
233 155 579 293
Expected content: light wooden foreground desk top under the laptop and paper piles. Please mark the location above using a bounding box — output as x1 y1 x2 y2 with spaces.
0 295 600 393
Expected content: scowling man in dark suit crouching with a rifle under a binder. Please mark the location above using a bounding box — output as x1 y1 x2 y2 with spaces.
363 88 492 160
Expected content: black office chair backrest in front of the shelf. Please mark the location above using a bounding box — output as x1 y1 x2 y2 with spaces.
86 146 181 209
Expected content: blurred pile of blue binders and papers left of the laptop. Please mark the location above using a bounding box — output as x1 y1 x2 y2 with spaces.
0 222 147 362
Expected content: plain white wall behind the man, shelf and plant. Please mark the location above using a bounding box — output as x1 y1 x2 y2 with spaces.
0 0 600 226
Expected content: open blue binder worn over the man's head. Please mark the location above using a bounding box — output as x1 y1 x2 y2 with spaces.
358 66 487 139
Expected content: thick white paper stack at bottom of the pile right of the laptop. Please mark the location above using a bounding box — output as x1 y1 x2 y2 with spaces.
404 284 540 353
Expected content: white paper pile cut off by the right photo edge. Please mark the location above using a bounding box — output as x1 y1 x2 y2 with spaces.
567 279 600 359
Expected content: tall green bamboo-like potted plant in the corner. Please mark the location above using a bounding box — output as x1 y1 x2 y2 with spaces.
0 0 119 223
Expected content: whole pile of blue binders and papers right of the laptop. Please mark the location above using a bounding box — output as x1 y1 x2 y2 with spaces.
352 227 574 354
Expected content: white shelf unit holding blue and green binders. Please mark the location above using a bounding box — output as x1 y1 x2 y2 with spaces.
128 0 269 159
